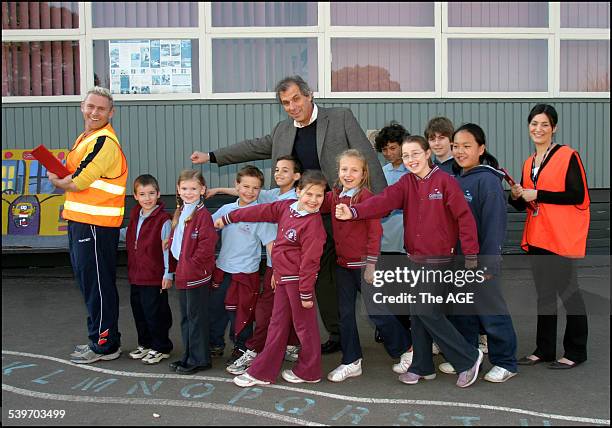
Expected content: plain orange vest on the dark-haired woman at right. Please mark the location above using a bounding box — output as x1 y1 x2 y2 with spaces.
521 146 591 258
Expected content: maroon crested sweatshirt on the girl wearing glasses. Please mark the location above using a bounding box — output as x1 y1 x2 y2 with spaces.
351 166 479 263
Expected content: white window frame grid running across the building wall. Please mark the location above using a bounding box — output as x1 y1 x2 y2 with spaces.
2 2 610 104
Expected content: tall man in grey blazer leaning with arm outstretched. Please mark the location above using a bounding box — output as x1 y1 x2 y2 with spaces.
191 76 387 353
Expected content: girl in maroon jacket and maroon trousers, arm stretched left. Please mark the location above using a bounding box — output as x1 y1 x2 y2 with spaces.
215 171 327 387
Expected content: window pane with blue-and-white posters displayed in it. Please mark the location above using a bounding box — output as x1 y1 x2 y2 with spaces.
93 39 200 94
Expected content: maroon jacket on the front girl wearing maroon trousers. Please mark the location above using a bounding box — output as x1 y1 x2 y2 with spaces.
222 200 327 301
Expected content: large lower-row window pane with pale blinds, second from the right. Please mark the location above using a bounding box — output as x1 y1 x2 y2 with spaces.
448 39 548 92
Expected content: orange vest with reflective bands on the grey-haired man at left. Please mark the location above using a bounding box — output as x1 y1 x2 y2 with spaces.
62 123 128 227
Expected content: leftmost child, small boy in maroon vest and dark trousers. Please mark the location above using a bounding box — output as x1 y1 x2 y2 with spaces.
121 174 173 364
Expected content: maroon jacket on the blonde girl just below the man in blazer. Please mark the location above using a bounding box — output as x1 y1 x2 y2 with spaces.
321 188 382 269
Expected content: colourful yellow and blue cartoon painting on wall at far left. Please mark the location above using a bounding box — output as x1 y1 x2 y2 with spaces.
2 150 68 236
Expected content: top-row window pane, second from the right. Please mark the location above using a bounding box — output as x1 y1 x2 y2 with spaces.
448 2 548 28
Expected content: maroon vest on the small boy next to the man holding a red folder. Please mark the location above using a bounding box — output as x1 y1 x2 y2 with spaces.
125 201 170 287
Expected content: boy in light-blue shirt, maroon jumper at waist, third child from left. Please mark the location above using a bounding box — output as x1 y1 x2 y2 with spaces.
210 165 275 365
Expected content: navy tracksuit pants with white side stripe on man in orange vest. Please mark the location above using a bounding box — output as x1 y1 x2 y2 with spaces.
68 221 121 354
